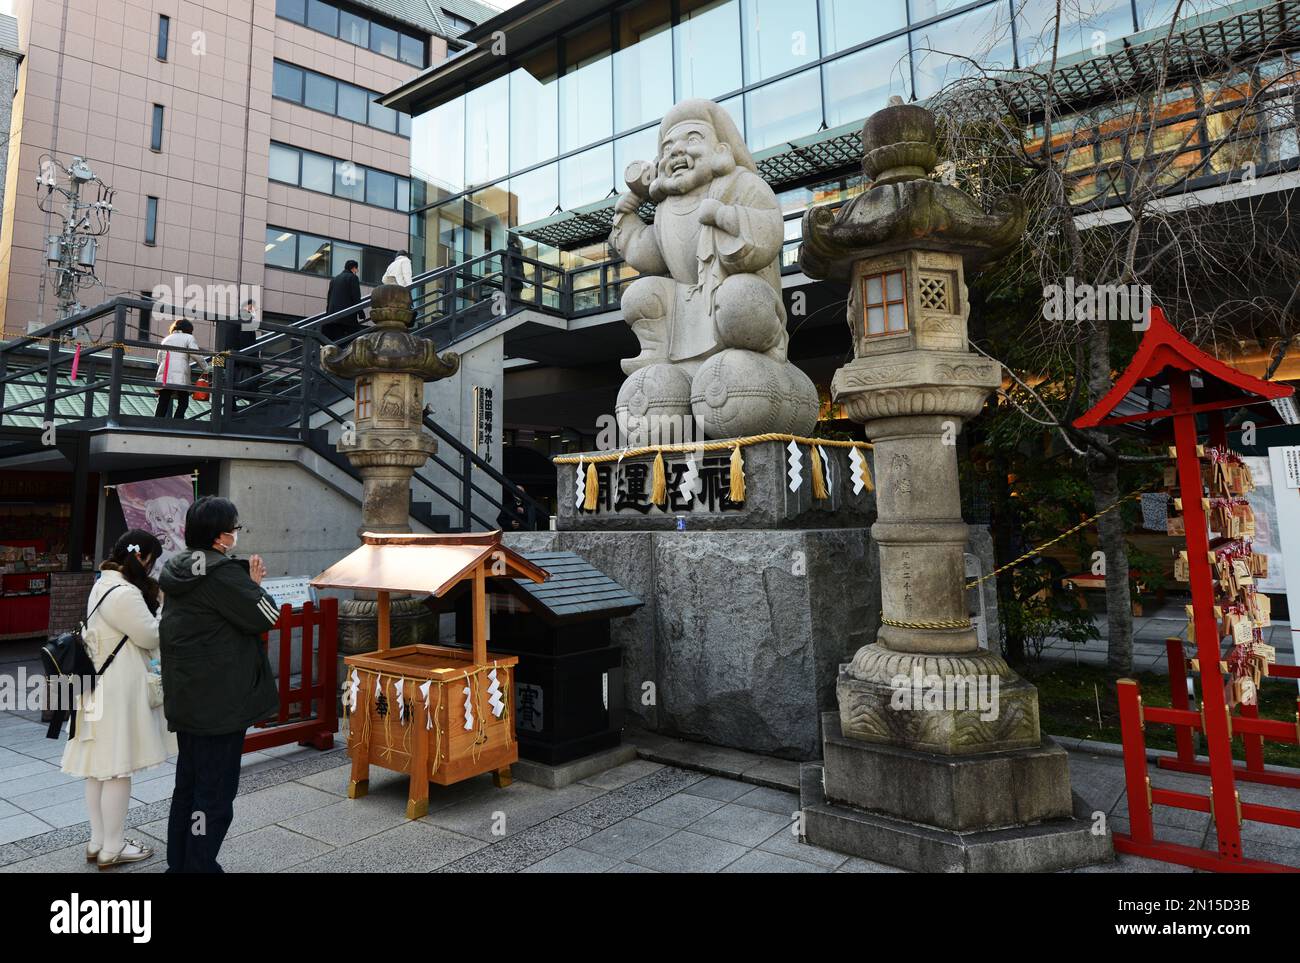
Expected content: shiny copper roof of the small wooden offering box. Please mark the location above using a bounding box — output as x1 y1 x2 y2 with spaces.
312 532 547 595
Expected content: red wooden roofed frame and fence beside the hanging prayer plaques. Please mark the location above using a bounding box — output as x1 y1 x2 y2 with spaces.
1074 307 1300 872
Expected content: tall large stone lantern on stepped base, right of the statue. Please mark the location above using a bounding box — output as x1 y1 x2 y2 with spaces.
800 97 1097 869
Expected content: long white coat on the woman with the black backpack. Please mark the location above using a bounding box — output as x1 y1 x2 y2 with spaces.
61 571 177 780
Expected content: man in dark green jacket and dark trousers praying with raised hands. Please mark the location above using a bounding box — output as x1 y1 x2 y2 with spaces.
159 495 280 872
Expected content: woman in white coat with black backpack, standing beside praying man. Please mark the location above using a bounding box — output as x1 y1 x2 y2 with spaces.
62 529 177 869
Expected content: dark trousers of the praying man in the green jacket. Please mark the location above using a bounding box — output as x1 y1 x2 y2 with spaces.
166 730 244 873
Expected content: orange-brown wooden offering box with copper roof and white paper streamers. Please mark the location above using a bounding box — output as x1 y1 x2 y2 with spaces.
312 532 546 819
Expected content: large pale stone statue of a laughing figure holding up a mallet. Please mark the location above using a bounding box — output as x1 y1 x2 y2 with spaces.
610 100 818 443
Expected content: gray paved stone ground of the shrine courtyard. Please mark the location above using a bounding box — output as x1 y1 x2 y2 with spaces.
0 696 1300 872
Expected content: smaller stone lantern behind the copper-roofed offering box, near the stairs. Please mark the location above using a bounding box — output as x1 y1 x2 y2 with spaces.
321 285 460 660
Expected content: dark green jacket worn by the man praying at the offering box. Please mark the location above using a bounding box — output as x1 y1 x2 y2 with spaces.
159 550 280 736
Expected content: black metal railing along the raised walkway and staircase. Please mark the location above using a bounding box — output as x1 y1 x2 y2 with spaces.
0 261 553 532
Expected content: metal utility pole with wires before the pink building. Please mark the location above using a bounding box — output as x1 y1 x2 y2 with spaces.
36 155 114 328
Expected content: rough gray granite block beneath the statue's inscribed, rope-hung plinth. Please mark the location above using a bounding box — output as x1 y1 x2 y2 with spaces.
504 528 880 760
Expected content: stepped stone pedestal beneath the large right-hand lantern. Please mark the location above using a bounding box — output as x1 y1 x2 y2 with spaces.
800 712 1114 872
